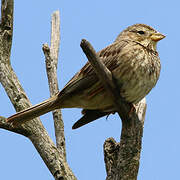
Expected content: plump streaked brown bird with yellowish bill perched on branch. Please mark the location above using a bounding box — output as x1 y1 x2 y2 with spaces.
6 24 165 129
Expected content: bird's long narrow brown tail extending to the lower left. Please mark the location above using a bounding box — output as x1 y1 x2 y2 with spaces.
6 96 57 125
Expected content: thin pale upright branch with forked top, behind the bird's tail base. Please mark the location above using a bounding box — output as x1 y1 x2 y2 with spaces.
43 11 66 160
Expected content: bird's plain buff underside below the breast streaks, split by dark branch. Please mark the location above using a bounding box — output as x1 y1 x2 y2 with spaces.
62 64 158 111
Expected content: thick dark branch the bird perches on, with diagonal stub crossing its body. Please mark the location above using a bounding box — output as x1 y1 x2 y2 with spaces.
81 39 146 180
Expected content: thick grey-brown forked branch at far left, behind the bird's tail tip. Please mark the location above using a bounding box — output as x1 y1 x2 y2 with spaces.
0 0 76 180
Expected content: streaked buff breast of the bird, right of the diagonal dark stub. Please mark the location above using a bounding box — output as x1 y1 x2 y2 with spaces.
115 47 160 103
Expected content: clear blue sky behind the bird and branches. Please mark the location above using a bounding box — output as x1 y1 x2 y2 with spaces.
0 0 180 180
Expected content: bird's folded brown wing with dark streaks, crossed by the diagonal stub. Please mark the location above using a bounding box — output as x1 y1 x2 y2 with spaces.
58 41 128 98
